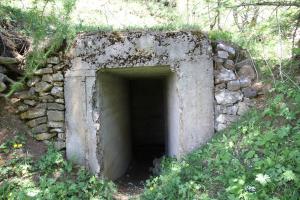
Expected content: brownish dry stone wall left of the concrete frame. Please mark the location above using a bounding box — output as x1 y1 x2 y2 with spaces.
11 56 66 149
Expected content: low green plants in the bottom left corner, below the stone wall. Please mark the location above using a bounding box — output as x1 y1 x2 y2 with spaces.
0 143 116 200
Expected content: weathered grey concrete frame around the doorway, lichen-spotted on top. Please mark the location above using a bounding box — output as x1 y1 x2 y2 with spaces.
65 31 214 175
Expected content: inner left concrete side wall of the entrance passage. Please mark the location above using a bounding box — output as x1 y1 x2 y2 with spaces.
98 73 131 180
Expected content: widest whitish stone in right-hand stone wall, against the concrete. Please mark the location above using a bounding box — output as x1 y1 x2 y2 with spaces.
215 90 243 105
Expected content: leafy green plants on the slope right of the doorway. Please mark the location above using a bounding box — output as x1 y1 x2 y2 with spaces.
141 83 300 200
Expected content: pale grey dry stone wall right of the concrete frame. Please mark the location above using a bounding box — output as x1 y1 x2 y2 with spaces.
213 42 259 131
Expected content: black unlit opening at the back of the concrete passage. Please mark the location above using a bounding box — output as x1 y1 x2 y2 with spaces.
117 77 167 193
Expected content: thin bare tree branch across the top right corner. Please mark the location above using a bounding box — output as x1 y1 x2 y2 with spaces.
228 1 300 8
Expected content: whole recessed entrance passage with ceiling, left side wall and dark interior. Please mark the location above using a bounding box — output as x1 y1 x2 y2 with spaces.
97 66 173 182
